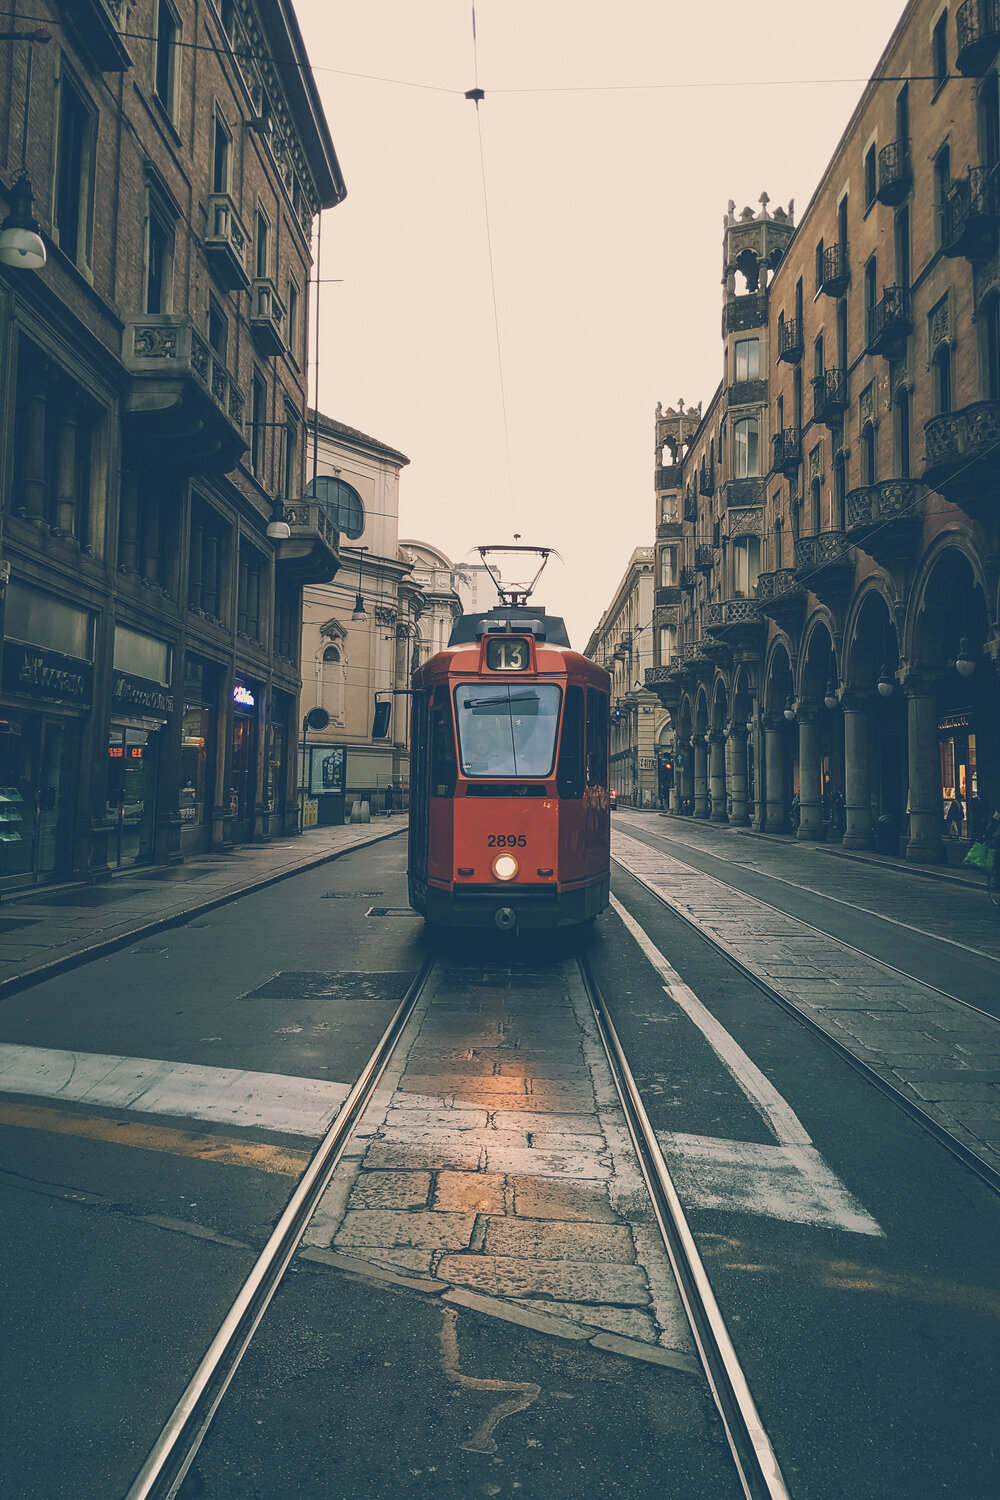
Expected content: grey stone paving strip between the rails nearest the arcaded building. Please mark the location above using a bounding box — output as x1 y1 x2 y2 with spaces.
612 819 1000 1169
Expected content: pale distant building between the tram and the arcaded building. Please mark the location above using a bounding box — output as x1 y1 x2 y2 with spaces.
583 548 673 807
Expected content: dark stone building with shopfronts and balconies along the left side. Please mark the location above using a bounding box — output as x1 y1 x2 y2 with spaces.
0 0 345 885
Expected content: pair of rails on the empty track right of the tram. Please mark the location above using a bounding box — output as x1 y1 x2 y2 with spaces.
612 855 1000 1194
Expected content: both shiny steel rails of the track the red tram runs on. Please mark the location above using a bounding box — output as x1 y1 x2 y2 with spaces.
124 936 789 1500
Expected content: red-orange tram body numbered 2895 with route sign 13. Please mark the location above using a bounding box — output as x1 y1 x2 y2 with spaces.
409 602 610 932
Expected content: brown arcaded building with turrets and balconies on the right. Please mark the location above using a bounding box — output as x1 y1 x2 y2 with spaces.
646 0 1000 863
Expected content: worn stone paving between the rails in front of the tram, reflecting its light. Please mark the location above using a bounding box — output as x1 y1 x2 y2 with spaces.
306 962 694 1370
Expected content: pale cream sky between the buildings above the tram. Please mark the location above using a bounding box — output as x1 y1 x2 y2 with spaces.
295 0 903 650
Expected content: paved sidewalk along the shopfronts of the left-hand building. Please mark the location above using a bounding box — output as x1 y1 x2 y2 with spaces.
0 815 408 998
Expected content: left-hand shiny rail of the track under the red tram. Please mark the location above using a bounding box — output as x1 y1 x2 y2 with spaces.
124 959 433 1500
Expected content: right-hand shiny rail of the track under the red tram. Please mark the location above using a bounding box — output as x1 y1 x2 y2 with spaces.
577 959 792 1500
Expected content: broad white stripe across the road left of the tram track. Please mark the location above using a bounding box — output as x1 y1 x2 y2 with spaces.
0 1043 351 1136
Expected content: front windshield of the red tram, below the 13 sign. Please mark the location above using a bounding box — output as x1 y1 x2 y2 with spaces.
454 683 562 776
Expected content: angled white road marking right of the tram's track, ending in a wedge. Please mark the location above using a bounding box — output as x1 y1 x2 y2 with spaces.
612 896 885 1235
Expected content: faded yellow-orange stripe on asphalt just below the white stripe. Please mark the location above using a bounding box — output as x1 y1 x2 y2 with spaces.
0 1104 310 1178
